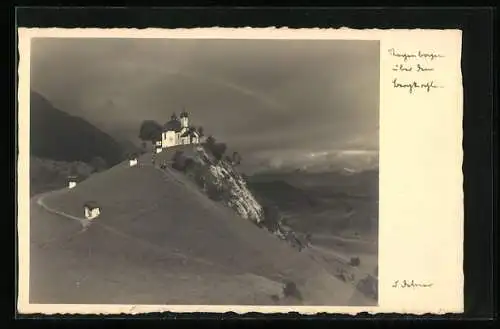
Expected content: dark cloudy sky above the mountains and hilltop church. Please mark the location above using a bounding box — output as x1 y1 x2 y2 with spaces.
31 38 379 165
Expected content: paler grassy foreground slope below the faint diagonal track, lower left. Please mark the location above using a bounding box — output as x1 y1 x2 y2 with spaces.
30 196 284 305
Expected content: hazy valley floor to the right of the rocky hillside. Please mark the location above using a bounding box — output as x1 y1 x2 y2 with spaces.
249 170 378 299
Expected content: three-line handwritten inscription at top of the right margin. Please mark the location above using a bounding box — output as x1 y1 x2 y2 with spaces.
388 48 444 94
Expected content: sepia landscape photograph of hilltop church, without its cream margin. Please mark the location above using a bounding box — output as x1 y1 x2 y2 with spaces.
29 37 381 306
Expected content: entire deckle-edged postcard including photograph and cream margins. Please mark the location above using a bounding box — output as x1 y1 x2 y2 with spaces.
17 27 463 314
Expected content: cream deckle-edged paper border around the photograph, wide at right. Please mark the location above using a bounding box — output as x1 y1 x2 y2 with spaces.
18 27 463 314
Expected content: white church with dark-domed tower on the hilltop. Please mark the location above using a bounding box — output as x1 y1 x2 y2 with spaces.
161 111 203 148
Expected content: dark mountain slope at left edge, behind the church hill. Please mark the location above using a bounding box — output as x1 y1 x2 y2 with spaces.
30 91 122 165
